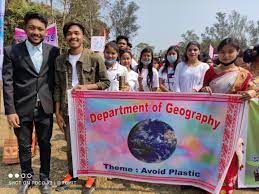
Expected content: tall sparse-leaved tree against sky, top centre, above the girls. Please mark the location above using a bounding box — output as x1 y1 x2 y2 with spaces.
109 0 139 38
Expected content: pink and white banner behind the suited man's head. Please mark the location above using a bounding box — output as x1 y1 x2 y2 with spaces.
14 24 58 47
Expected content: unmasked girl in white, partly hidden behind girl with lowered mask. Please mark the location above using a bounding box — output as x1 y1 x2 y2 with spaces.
120 50 138 92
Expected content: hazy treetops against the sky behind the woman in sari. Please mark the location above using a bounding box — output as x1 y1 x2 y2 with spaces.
180 11 259 53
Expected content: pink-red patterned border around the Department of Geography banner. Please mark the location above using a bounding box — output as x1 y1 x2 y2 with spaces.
72 91 243 190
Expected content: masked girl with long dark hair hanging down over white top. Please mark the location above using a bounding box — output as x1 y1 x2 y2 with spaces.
138 48 159 92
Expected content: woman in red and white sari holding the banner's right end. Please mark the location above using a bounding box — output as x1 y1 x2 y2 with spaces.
201 38 255 194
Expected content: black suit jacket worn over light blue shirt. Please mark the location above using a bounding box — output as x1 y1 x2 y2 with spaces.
2 42 59 120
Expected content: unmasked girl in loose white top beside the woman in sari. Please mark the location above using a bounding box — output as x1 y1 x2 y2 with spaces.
175 41 209 92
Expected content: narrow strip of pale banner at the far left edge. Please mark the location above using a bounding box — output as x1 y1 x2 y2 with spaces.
0 0 5 76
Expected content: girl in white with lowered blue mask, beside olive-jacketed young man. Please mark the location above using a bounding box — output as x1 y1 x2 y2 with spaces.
104 42 129 92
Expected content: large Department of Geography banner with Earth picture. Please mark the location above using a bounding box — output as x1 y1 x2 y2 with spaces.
68 91 244 193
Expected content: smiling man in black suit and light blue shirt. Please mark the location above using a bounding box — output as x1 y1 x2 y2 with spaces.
2 12 59 193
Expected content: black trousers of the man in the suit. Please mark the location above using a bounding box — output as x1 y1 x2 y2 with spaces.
14 106 53 181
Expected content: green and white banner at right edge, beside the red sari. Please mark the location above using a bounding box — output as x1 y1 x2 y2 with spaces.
238 99 259 188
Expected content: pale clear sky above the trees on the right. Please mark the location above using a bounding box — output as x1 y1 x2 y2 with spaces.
131 0 259 52
